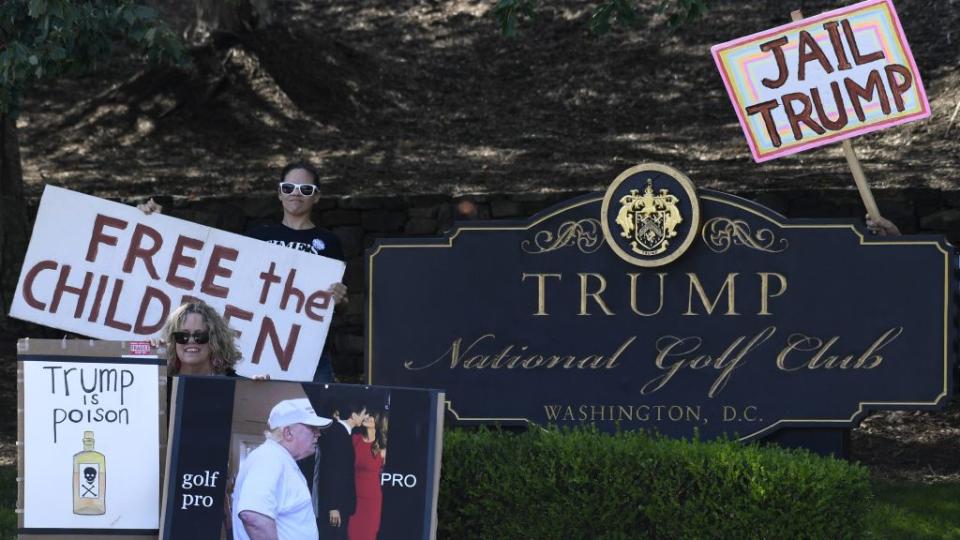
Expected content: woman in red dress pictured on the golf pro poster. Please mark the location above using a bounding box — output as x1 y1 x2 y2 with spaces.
347 413 387 540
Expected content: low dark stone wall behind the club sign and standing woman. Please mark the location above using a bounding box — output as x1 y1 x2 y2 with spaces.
110 189 960 381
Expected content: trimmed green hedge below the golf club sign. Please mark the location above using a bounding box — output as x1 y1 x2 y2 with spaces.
439 430 872 539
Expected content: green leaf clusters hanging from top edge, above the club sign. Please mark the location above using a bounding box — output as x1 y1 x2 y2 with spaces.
493 0 709 36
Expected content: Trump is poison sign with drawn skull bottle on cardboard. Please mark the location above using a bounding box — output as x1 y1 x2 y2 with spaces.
17 339 167 539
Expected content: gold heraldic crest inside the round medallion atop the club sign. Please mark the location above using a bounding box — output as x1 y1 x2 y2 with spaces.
616 178 683 256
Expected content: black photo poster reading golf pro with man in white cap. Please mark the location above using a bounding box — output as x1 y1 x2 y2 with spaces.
160 376 444 540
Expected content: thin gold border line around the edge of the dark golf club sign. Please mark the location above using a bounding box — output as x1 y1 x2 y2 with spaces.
366 194 955 441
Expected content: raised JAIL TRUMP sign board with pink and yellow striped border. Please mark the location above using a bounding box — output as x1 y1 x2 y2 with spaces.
711 0 930 162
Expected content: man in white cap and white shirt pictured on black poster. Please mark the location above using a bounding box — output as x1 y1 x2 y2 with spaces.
231 398 333 540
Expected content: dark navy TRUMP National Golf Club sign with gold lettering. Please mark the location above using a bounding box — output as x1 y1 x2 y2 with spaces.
367 166 957 439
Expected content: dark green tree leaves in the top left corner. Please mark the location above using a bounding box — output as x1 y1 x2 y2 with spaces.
0 0 184 114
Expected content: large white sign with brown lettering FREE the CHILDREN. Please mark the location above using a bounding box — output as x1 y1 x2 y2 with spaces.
10 186 344 381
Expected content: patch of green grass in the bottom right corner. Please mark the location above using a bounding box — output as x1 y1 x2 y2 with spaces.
868 483 960 540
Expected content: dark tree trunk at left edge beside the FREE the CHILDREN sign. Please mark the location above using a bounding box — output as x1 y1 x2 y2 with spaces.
0 114 30 329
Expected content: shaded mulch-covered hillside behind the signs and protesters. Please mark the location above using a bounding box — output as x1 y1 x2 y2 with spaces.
0 0 960 490
